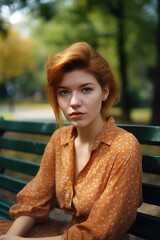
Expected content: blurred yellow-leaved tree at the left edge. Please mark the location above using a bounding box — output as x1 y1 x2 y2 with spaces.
0 28 34 82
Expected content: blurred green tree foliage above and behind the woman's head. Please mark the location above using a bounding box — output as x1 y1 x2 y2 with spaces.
0 0 159 124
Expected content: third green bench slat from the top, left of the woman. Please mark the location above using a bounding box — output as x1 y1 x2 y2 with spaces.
0 156 39 176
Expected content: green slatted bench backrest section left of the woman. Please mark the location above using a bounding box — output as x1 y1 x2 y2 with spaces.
0 120 56 193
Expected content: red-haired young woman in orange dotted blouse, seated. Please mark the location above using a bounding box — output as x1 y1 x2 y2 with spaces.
0 42 142 240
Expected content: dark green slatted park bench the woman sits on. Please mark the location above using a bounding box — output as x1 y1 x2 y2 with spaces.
0 119 160 240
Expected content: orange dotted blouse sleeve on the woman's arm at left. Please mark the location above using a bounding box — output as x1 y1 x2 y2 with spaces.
9 132 55 222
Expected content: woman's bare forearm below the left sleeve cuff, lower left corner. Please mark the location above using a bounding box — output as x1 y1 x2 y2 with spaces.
6 216 35 237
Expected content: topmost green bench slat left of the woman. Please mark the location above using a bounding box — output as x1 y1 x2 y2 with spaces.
0 119 57 135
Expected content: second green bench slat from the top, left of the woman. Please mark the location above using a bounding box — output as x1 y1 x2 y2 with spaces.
0 137 46 155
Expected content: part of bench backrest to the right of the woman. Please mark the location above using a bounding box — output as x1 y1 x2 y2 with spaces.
119 124 160 240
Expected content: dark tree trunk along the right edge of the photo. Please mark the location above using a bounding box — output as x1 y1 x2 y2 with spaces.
151 0 160 125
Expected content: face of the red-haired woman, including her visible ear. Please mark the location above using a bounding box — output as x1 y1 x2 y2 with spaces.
57 70 109 128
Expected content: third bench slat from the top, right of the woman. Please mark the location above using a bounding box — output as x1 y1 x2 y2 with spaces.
143 183 160 206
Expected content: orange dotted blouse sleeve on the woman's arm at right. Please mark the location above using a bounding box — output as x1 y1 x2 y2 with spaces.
63 133 142 240
